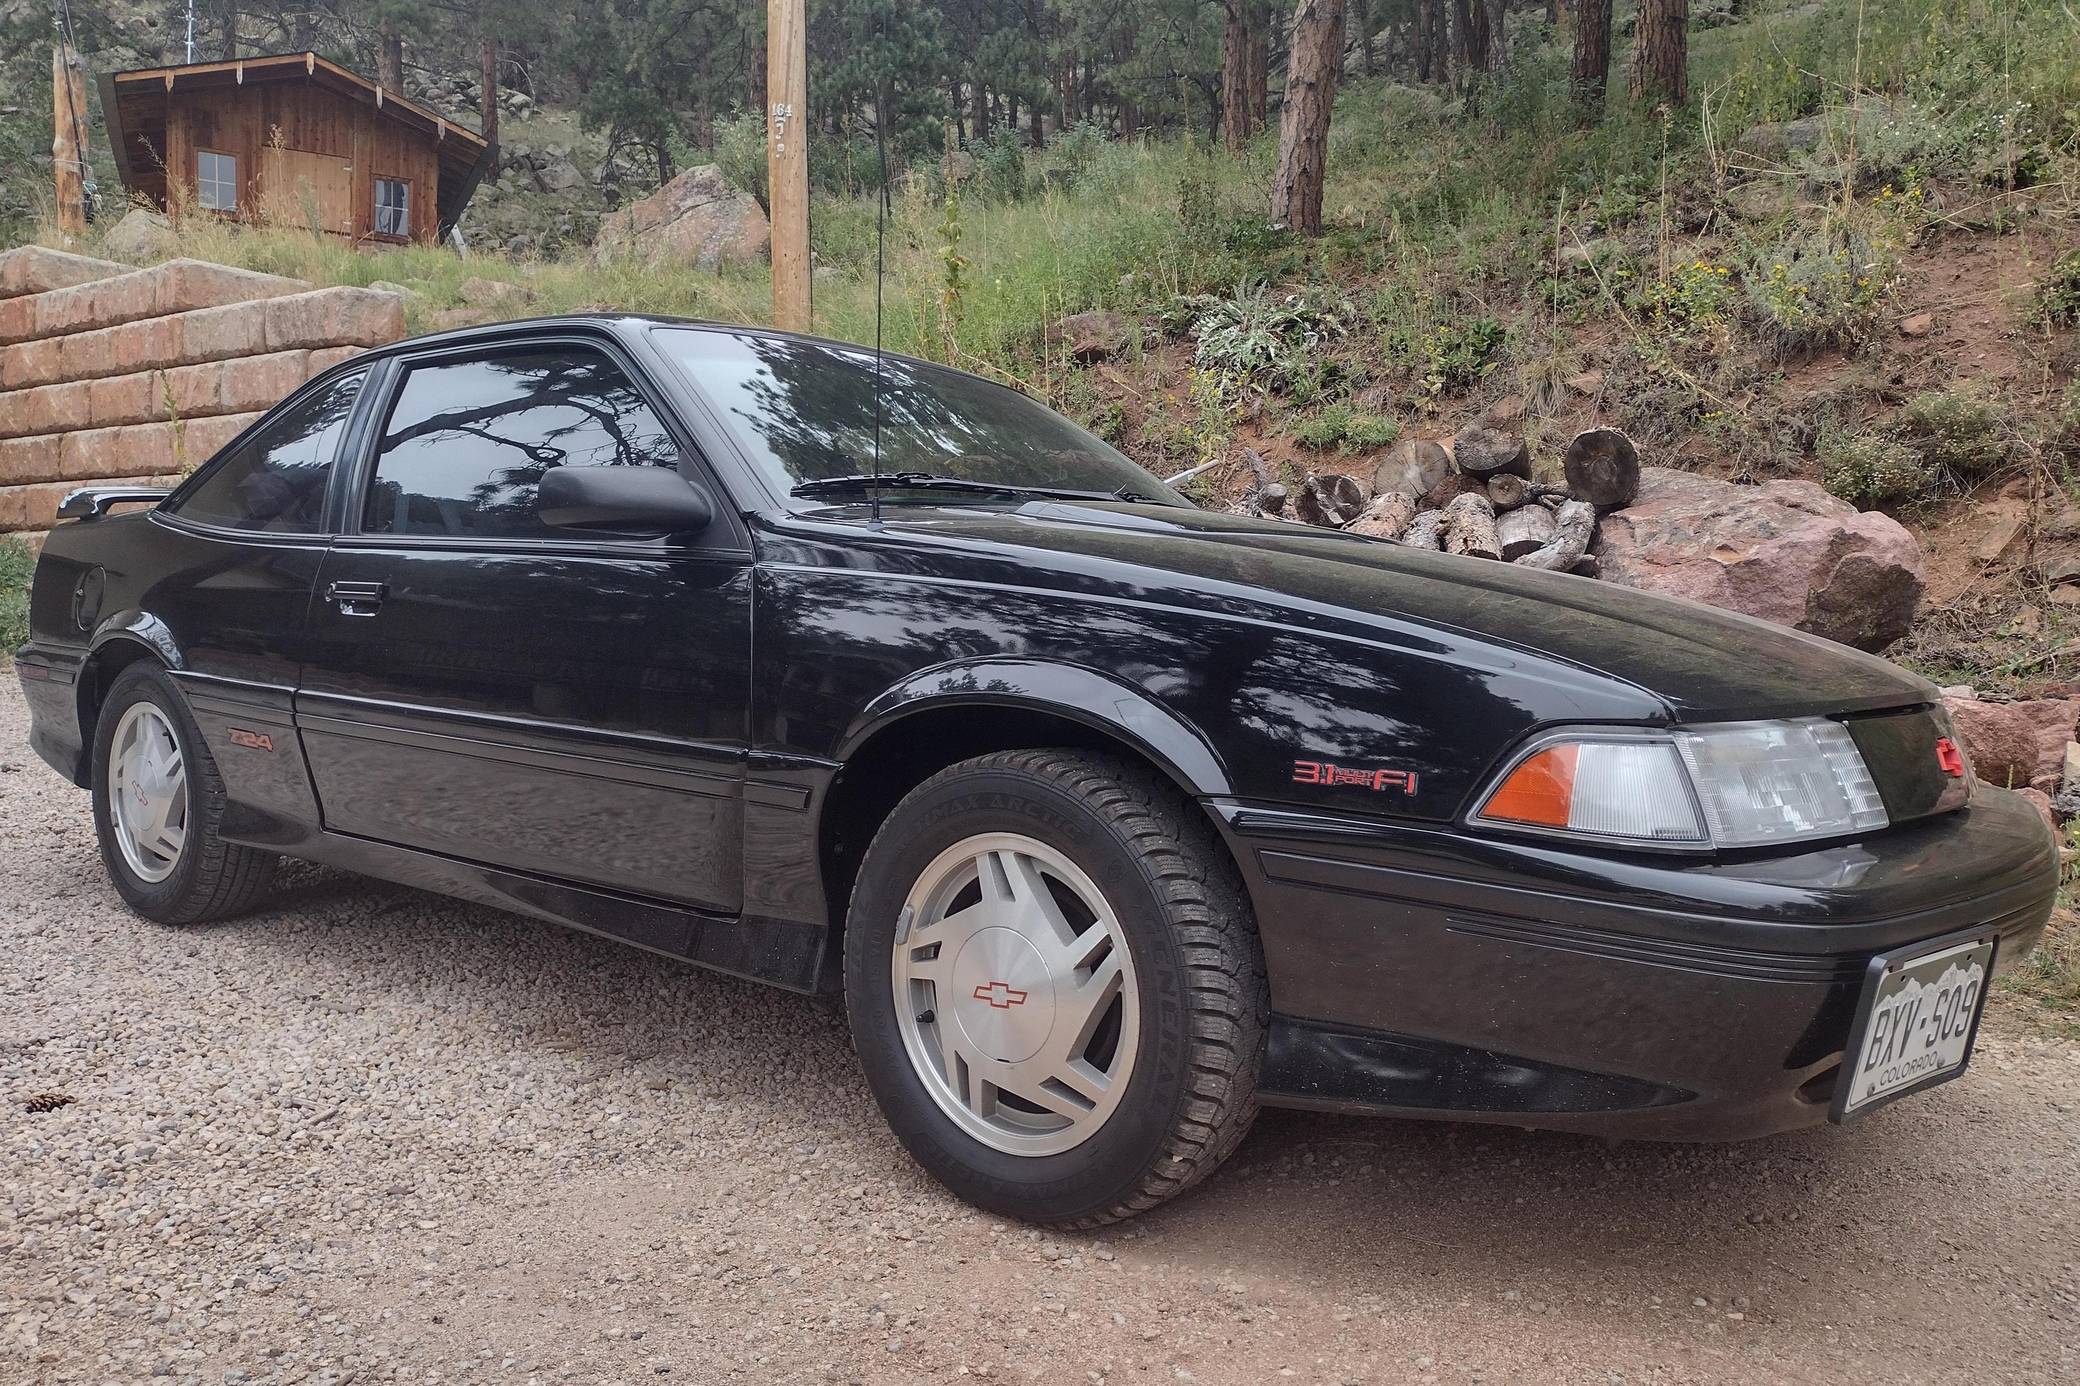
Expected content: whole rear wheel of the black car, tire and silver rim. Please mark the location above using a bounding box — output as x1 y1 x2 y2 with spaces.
94 662 281 924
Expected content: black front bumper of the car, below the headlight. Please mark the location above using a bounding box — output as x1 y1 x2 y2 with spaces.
1208 785 2057 1140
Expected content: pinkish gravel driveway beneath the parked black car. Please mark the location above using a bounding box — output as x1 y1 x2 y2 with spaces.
0 670 2080 1386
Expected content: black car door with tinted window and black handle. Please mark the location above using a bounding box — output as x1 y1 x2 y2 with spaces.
297 337 751 914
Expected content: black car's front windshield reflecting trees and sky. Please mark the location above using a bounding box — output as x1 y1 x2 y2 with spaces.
657 327 1190 506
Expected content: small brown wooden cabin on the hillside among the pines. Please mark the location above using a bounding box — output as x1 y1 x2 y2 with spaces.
100 52 497 246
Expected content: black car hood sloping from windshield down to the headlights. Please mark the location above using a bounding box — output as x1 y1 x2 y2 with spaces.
811 502 1936 722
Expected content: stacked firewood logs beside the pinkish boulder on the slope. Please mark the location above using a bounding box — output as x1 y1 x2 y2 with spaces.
1244 422 1639 574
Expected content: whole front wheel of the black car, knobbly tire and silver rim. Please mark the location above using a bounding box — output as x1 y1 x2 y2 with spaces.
844 749 1269 1228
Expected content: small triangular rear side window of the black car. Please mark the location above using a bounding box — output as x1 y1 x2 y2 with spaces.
171 373 364 535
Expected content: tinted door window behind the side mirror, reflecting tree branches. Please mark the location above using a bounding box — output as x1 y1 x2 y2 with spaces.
362 345 678 539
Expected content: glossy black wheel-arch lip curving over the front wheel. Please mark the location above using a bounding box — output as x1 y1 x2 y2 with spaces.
838 658 1233 799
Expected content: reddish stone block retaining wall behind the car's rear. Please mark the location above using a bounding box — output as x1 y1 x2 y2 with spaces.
0 246 404 541
